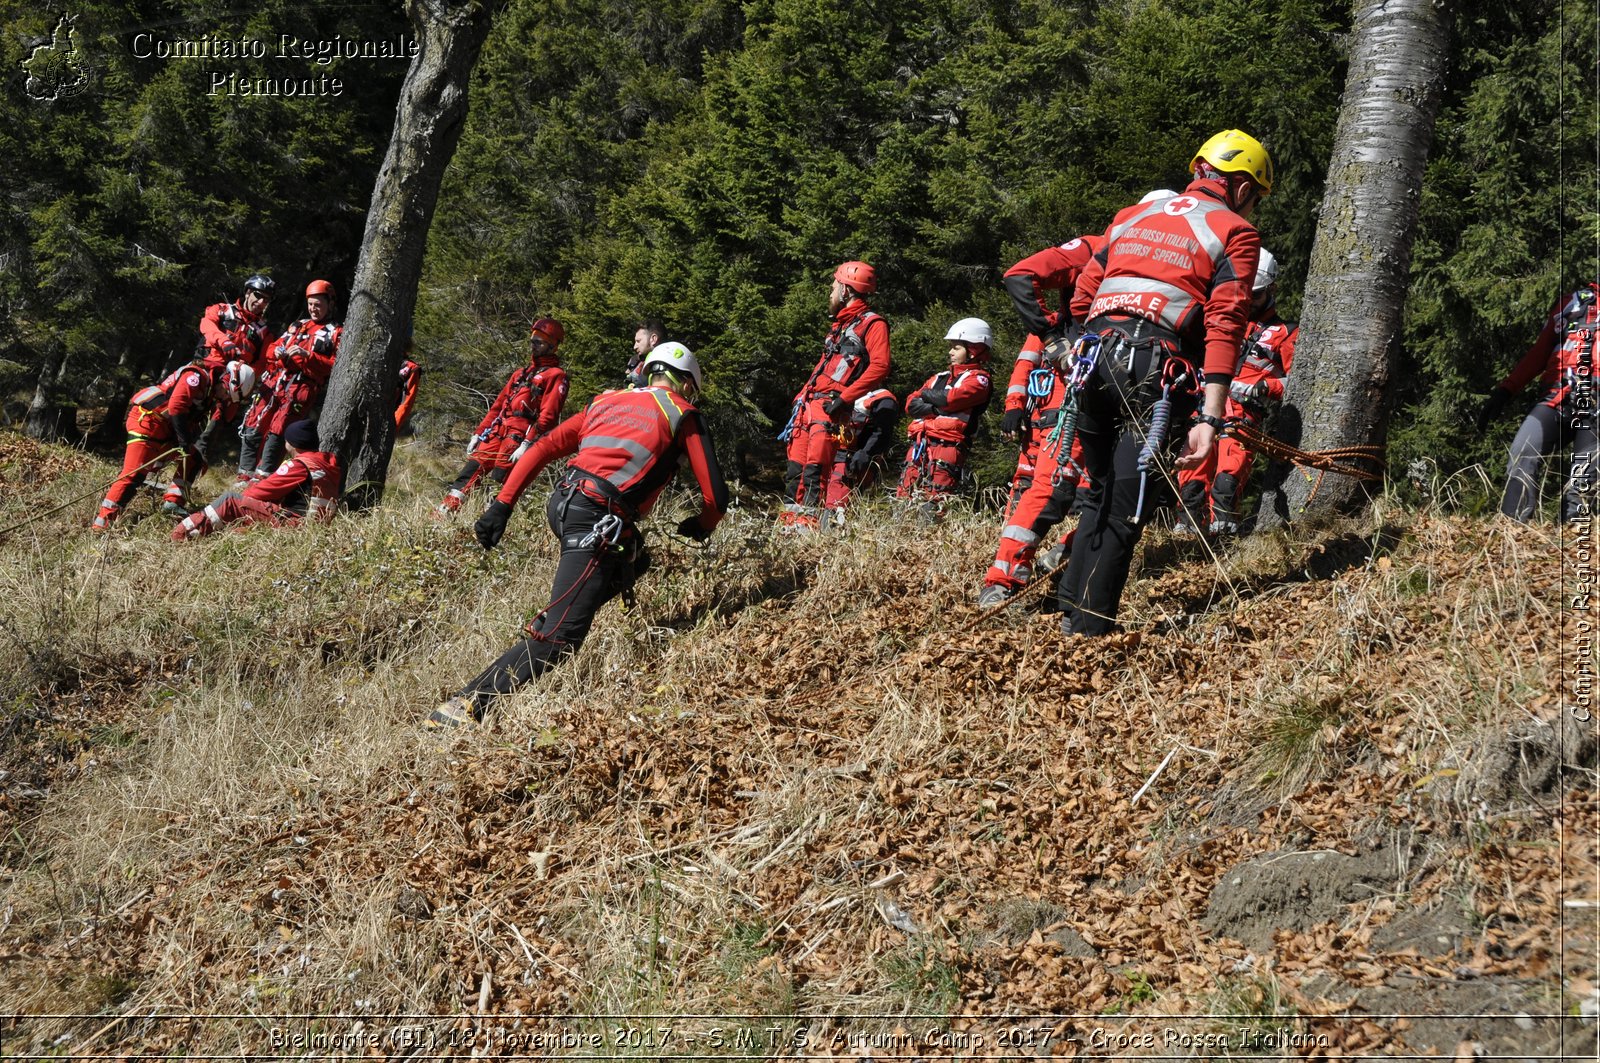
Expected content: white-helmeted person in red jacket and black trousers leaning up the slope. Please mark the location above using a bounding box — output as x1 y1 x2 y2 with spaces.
426 343 728 728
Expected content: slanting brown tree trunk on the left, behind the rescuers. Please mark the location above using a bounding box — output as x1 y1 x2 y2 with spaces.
318 0 504 507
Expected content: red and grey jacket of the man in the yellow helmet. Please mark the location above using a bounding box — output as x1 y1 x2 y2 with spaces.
1072 178 1261 381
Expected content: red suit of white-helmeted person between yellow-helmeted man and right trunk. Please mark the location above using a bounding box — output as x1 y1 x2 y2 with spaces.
1178 307 1299 533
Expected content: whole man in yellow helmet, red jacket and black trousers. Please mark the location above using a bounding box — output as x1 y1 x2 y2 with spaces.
1045 130 1272 634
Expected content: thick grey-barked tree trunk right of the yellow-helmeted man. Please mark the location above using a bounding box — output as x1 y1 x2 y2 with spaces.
1261 0 1451 525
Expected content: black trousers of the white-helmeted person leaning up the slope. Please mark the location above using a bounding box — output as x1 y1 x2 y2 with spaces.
461 487 648 712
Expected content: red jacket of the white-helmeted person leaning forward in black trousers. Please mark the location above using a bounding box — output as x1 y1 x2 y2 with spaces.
496 387 728 532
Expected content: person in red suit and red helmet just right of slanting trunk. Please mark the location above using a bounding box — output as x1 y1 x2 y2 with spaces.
438 317 568 514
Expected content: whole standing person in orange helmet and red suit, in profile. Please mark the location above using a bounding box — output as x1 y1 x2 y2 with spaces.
782 261 890 530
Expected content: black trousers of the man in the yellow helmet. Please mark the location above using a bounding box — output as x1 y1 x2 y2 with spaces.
1058 346 1197 636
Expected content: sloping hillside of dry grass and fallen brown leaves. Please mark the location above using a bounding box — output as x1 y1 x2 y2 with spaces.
0 435 1600 1060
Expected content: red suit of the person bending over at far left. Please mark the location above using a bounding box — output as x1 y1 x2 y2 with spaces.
94 362 222 530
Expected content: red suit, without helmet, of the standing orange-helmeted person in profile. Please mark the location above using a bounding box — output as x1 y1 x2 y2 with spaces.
784 298 890 512
